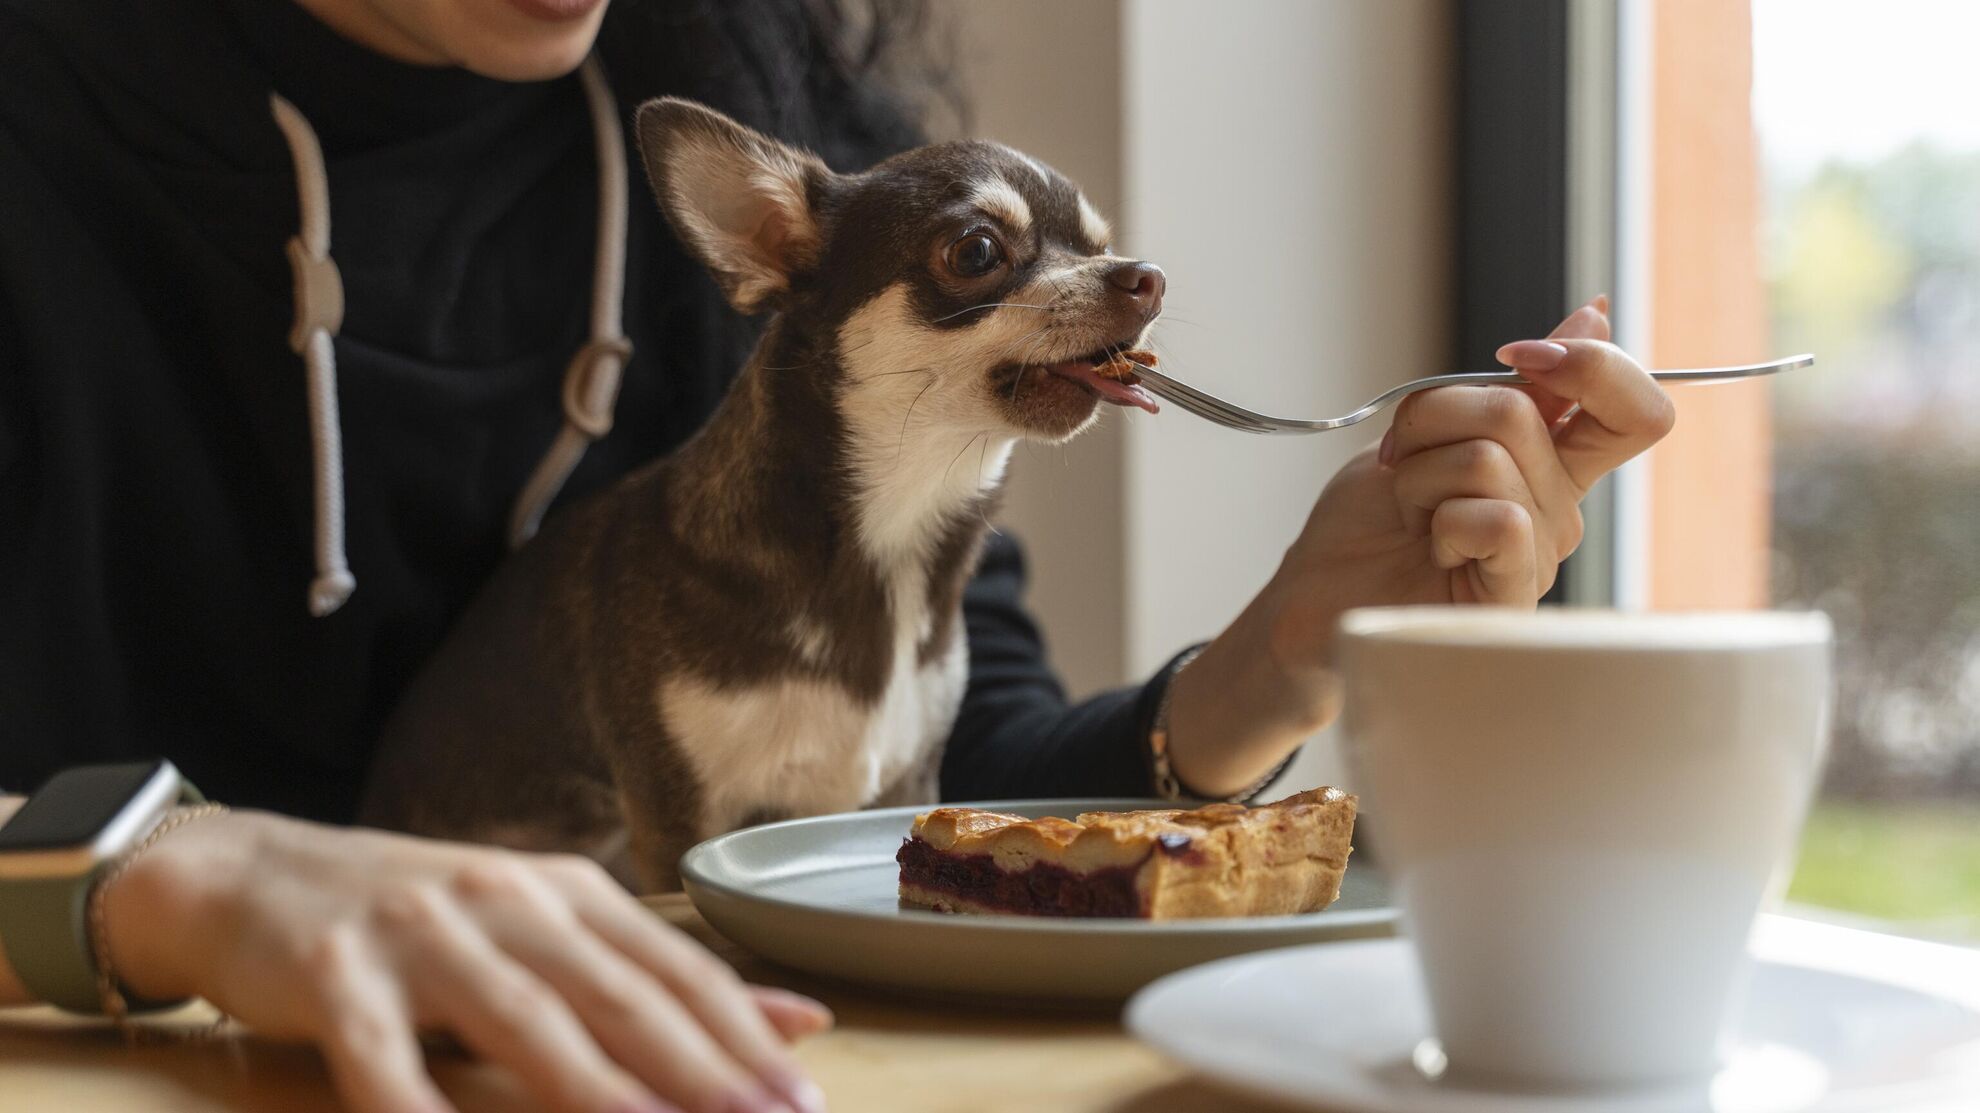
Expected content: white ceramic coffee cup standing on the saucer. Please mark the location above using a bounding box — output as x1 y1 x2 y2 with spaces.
1340 606 1832 1089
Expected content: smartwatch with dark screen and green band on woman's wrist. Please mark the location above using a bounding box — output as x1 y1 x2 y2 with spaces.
0 760 204 1012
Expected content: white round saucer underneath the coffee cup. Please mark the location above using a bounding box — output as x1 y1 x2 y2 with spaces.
1127 917 1980 1113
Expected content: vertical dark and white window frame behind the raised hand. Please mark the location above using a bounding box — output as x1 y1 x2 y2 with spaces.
1451 0 1649 608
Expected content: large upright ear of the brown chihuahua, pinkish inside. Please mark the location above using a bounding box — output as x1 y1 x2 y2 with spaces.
636 97 832 313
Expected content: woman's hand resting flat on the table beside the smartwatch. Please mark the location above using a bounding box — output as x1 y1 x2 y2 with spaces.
103 812 832 1113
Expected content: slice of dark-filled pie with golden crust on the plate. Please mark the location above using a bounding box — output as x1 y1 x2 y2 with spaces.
895 788 1354 919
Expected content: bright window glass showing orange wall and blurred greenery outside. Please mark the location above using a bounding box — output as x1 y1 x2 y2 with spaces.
1647 0 1980 941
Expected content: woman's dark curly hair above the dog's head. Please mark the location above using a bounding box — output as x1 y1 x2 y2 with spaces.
598 0 962 170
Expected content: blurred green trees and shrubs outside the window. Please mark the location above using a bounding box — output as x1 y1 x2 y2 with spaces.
1766 145 1980 814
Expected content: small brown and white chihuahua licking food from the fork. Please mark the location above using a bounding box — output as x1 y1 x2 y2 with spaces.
362 99 1164 889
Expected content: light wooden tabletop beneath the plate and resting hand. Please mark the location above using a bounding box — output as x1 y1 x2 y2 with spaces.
0 895 1269 1113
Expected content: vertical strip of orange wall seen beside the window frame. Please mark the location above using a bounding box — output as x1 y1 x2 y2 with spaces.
1649 0 1776 610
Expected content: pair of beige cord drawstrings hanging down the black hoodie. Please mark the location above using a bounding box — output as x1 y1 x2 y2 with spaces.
269 57 632 618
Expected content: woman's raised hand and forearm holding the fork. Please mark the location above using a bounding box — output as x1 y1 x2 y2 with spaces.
1170 297 1675 794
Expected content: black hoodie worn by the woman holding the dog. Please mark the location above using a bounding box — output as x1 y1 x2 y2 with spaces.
0 0 1158 820
